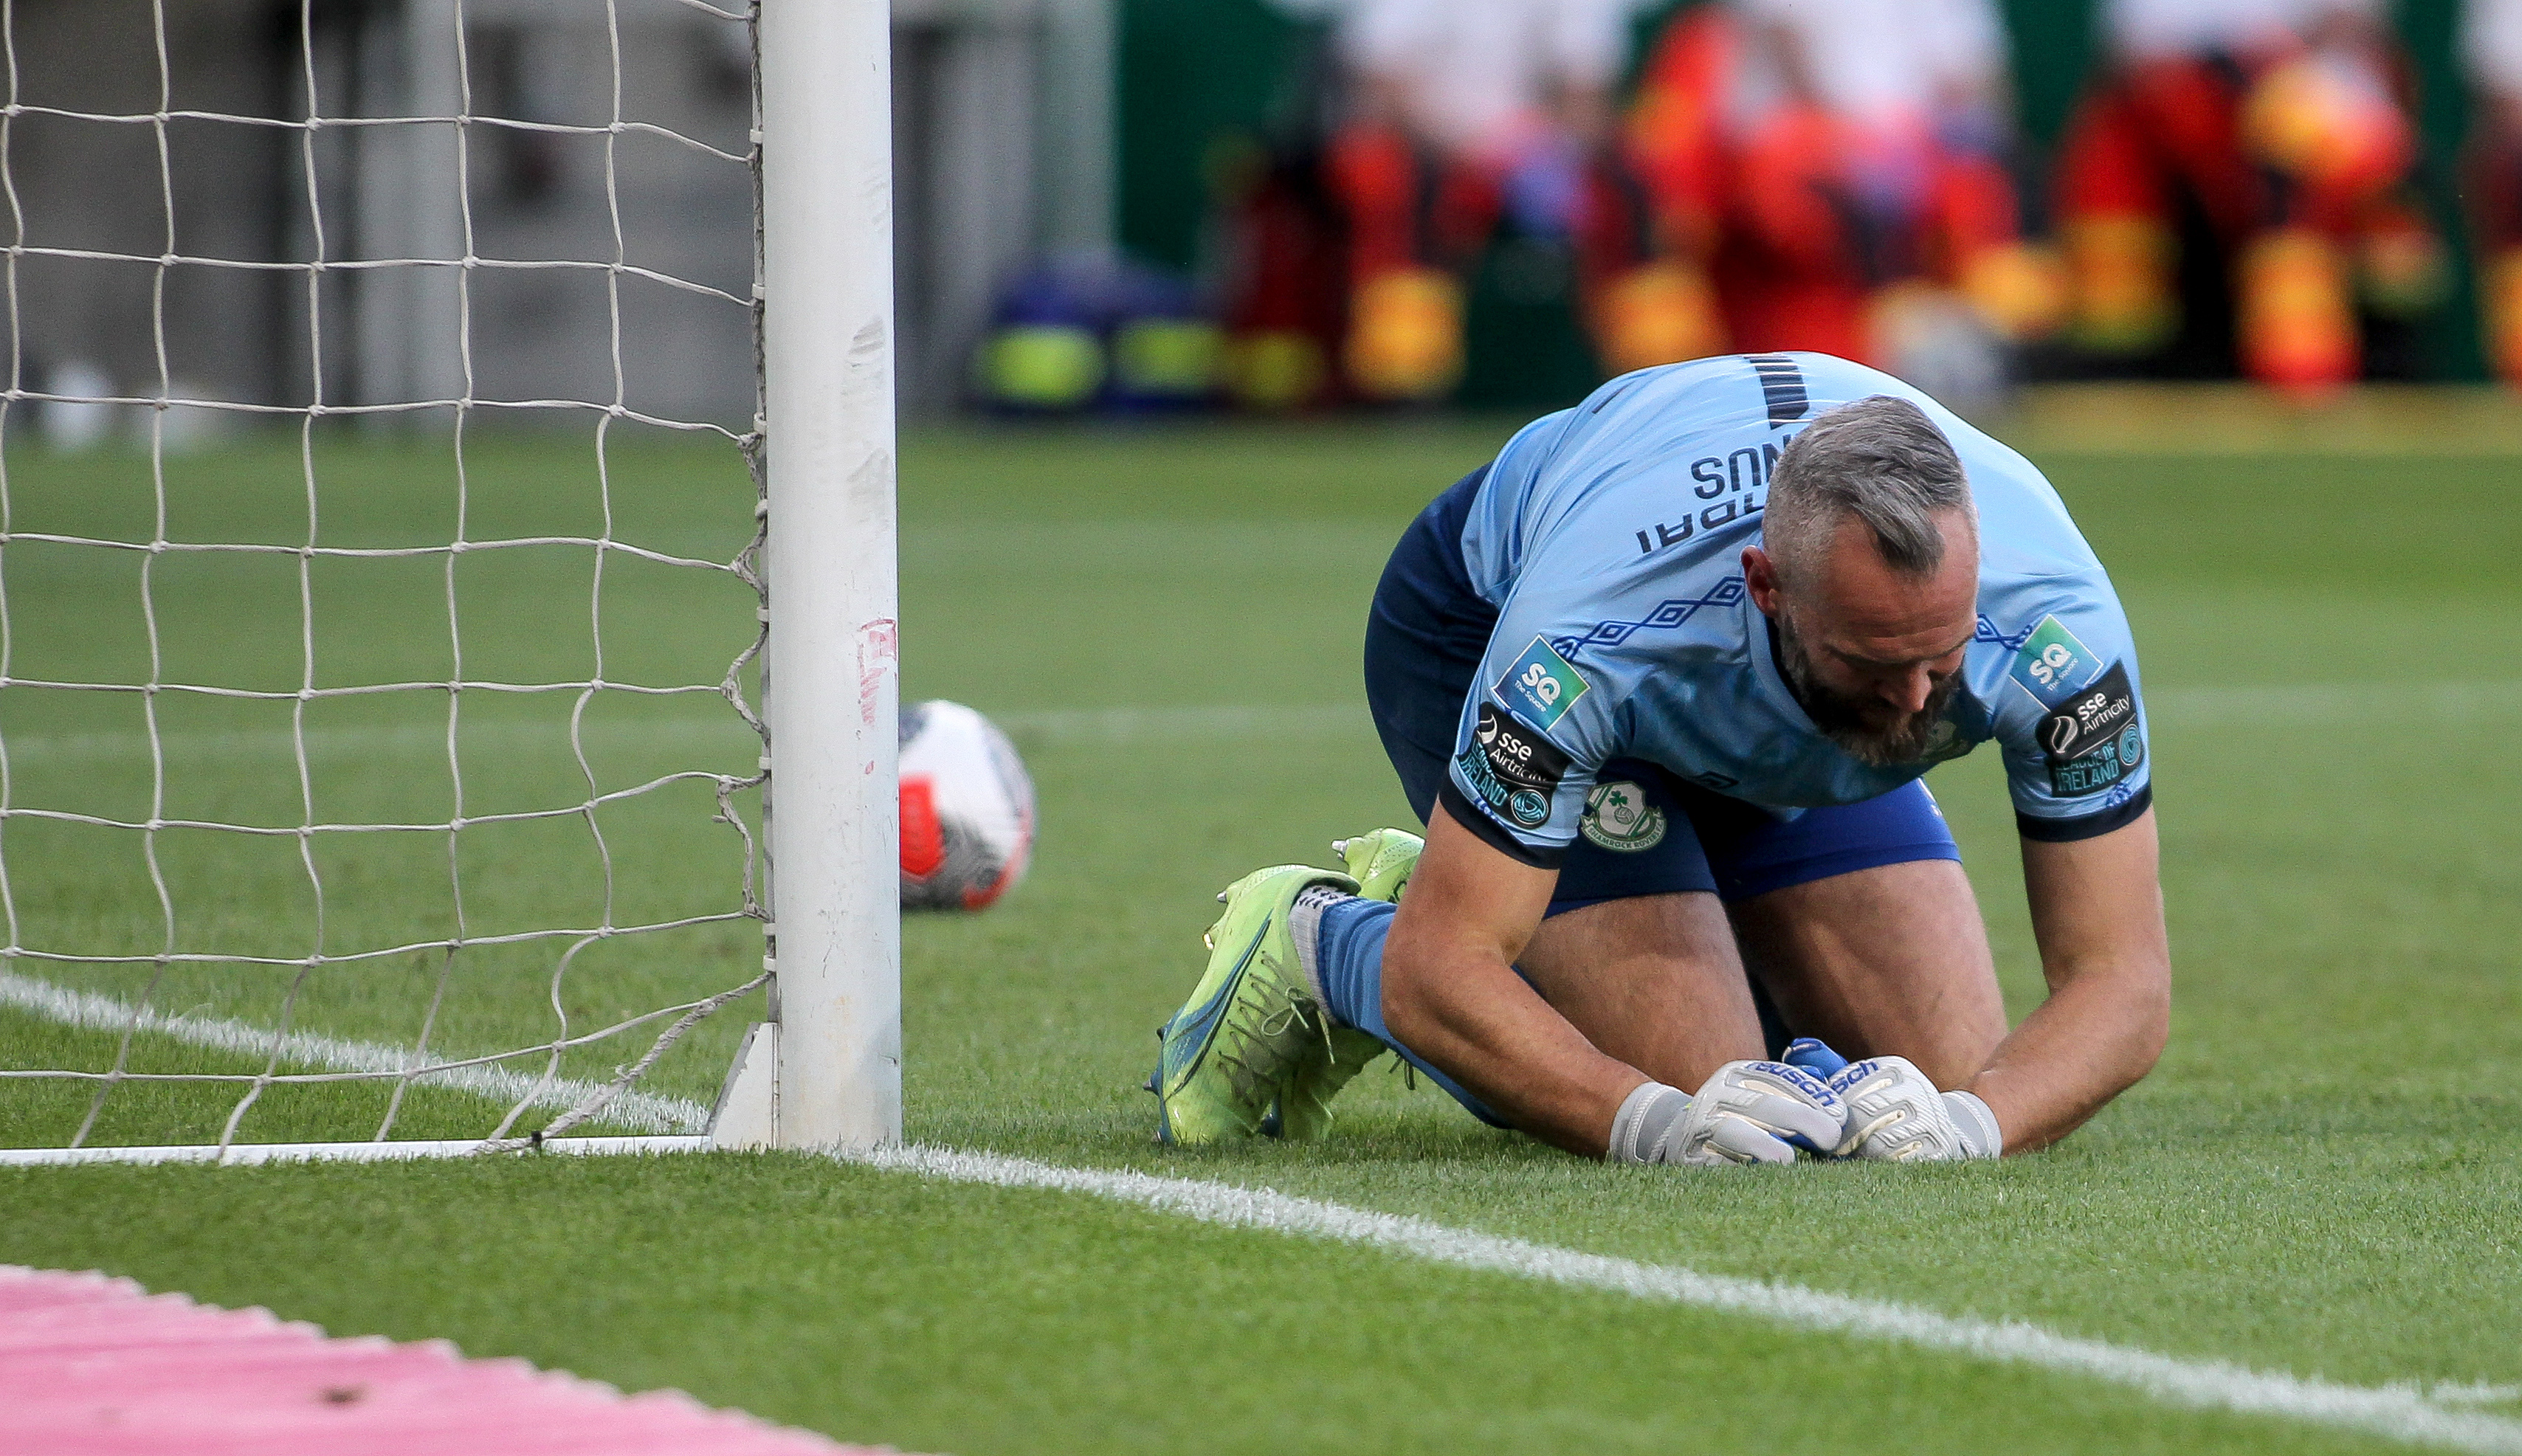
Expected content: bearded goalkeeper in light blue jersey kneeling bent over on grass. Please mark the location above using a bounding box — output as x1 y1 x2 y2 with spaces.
1150 353 2171 1163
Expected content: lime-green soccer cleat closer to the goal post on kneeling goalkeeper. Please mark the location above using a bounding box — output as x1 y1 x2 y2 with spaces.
1148 866 1357 1145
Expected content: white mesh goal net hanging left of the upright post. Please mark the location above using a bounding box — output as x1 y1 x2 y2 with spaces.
0 0 769 1145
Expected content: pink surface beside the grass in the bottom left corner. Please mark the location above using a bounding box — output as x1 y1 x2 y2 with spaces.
0 1264 908 1456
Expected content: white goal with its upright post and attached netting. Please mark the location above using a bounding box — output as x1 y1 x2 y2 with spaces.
0 0 903 1166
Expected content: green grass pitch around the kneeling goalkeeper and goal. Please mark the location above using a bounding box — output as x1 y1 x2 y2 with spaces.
0 413 2522 1456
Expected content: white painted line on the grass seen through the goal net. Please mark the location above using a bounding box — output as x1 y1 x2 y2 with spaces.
0 971 709 1133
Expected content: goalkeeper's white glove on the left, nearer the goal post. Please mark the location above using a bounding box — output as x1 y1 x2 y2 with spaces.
1609 1063 1846 1168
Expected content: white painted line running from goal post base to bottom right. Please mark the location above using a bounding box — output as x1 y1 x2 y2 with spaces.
845 1145 2522 1454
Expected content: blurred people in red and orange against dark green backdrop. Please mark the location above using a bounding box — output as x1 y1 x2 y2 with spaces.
971 0 2522 409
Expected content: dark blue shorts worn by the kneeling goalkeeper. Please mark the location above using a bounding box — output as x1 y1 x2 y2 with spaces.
1367 467 1962 916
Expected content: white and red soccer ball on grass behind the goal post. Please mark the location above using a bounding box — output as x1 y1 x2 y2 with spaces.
900 699 1034 911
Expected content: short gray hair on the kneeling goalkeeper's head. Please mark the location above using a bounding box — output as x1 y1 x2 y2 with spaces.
1760 393 1977 580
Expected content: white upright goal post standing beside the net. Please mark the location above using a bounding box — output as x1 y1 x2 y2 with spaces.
729 0 903 1148
